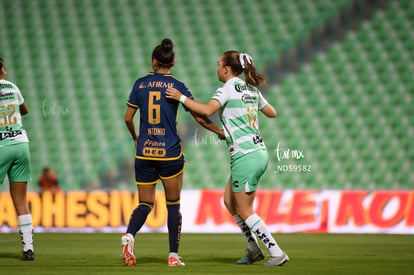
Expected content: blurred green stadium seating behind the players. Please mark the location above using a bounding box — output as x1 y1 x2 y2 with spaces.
0 0 414 190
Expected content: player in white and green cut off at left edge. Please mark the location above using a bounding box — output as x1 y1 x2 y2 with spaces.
0 58 34 261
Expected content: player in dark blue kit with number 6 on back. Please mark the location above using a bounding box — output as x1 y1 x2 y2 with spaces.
122 39 224 266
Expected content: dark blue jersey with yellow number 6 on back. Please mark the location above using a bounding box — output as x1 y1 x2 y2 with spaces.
128 73 192 160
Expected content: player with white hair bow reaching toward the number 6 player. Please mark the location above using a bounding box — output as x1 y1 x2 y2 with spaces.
167 51 289 266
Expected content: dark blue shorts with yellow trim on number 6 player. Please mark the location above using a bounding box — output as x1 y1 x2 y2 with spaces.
135 156 185 185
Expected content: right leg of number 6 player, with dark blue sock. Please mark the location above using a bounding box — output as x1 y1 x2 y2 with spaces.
160 159 185 266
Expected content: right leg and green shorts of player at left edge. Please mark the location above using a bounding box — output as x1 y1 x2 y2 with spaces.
9 143 34 261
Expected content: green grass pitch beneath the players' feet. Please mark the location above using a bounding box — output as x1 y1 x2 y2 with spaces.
0 233 414 275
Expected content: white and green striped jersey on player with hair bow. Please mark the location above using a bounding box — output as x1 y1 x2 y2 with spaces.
212 77 268 156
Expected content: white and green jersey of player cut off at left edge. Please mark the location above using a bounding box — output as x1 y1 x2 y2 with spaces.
0 79 29 147
